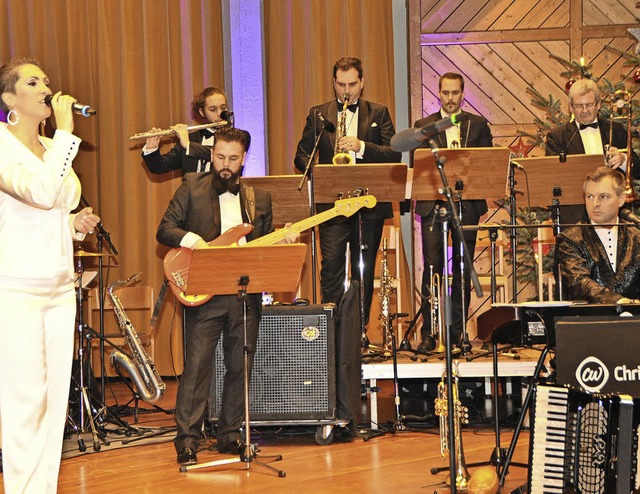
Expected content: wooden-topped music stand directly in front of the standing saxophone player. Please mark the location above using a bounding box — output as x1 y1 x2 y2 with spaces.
313 163 407 348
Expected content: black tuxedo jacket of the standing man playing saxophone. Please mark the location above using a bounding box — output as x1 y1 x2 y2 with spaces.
294 98 402 218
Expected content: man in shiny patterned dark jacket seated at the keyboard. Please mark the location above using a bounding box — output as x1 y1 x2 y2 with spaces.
555 167 640 304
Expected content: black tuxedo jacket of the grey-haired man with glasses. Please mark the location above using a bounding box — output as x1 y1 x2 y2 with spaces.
545 118 640 178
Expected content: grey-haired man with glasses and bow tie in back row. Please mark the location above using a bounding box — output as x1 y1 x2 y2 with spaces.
546 79 640 224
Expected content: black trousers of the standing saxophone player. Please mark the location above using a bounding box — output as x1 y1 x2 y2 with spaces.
320 214 384 325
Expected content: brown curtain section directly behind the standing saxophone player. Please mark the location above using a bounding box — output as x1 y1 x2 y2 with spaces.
264 0 395 175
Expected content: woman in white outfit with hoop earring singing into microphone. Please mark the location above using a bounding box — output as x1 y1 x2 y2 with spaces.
0 58 100 493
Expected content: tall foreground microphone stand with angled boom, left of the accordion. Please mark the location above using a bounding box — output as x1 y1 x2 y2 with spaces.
429 140 483 494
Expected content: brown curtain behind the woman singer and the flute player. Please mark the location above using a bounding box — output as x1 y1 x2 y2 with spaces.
0 0 224 375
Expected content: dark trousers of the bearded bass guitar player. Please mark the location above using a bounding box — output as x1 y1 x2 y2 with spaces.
174 295 261 450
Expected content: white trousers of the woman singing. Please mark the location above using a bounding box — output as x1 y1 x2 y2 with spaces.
0 273 76 494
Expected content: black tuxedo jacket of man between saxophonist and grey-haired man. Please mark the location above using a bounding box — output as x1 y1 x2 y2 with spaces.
413 111 493 223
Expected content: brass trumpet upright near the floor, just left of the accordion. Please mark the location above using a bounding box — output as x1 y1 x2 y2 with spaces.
435 361 471 490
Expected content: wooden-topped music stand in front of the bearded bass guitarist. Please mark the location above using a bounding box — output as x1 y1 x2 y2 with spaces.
180 244 307 477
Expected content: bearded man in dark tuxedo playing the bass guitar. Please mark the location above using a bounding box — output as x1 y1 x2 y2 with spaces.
156 127 293 465
